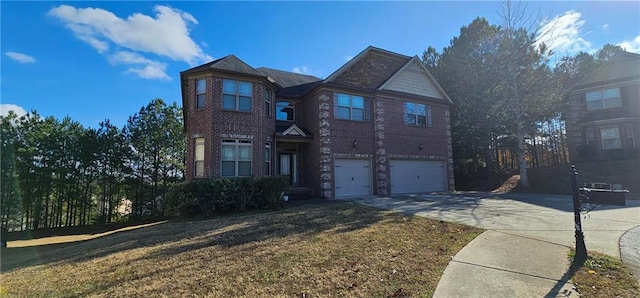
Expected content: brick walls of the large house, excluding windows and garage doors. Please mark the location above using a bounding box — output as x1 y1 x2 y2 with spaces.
181 48 454 198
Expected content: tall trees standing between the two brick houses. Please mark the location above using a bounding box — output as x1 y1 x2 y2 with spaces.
422 1 623 188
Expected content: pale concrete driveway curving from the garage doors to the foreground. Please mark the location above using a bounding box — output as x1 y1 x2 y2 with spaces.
345 193 640 297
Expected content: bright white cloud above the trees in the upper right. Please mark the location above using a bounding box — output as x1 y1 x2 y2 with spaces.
538 10 592 54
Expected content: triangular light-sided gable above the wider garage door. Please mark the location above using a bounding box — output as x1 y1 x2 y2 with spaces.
378 56 453 103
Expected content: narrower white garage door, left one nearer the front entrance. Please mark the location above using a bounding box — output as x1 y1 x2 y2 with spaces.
335 159 371 197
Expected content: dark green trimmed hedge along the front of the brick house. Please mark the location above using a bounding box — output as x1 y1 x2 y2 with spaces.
162 176 289 217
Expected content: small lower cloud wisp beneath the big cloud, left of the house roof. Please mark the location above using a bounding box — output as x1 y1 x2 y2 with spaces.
109 51 171 80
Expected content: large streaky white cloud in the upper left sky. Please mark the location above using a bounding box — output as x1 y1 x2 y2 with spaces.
48 5 213 79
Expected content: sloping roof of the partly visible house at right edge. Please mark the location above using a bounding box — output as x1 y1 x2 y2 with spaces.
571 52 640 92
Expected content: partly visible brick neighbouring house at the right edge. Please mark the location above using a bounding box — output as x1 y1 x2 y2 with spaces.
567 52 640 162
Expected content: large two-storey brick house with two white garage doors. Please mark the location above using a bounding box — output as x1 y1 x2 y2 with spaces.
180 47 454 198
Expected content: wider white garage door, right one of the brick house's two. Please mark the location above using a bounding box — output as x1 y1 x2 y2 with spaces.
391 160 445 194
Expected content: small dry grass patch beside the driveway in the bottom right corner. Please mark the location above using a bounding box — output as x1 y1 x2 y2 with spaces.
570 251 640 298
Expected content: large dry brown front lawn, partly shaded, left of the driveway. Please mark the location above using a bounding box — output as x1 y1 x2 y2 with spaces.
0 203 482 297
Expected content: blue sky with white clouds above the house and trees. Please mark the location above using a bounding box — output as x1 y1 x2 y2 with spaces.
0 1 640 127
